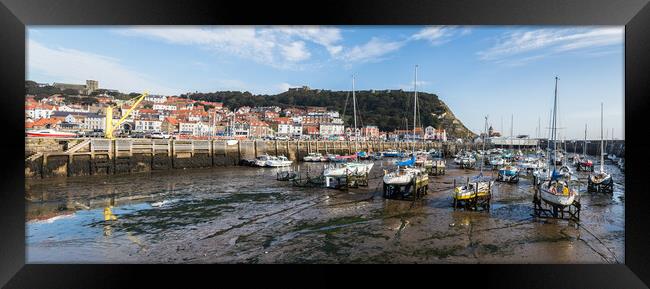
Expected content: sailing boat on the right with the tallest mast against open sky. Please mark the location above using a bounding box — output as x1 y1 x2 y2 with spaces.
539 76 576 206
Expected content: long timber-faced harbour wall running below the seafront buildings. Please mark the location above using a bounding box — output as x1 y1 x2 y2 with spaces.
25 138 475 178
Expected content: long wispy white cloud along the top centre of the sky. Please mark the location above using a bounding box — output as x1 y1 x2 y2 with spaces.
117 26 470 69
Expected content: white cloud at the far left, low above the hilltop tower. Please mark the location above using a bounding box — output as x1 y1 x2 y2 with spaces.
27 40 181 94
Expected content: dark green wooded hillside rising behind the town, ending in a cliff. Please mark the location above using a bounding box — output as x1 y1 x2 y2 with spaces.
182 89 476 138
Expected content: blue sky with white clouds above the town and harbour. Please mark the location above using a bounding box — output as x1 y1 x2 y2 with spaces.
26 26 624 139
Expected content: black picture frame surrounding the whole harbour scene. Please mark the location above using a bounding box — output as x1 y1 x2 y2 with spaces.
0 0 650 288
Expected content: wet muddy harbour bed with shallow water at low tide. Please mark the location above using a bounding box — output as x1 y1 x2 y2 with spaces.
26 159 625 263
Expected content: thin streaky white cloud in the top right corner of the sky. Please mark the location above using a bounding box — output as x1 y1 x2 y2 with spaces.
477 27 624 62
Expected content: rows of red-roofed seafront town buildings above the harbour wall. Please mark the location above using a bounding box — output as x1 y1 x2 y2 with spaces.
25 81 447 141
